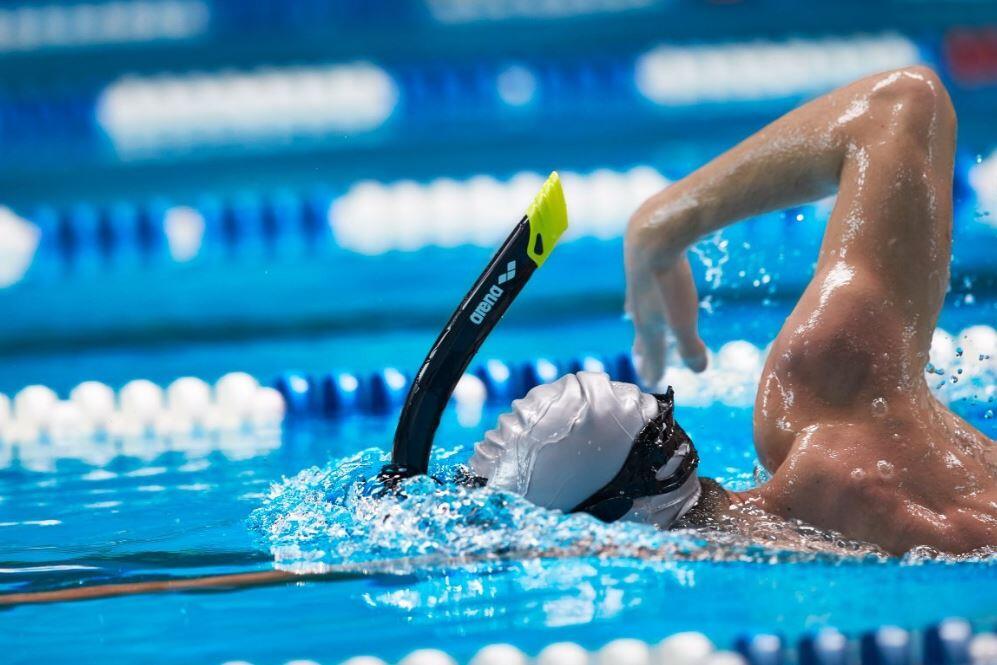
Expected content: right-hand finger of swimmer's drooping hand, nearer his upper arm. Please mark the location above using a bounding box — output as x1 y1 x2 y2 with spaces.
655 254 706 372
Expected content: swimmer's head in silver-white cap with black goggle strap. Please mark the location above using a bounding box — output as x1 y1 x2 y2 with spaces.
471 372 699 528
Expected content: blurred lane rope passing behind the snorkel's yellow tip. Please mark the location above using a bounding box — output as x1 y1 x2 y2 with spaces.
19 160 997 274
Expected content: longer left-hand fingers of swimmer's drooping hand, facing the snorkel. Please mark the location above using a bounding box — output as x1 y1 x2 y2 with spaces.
627 275 667 388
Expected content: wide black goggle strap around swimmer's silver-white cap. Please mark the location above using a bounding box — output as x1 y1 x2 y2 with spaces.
571 387 699 522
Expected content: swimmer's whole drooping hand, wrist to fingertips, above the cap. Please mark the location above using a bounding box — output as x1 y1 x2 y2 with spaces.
624 205 706 388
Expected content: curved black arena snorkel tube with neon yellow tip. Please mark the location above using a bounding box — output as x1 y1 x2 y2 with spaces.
381 172 568 482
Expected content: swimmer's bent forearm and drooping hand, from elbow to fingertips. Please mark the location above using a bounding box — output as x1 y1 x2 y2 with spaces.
624 67 933 385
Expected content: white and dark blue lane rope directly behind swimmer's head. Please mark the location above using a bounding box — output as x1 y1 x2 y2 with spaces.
0 325 997 445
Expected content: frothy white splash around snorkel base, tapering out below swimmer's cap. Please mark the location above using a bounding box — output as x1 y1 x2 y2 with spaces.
249 449 701 570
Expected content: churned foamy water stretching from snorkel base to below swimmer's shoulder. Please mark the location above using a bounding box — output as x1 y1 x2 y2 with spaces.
243 448 912 572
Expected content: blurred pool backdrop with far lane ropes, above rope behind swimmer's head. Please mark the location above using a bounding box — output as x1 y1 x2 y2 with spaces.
0 0 997 392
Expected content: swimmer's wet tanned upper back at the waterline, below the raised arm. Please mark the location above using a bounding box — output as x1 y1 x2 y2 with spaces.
759 420 997 554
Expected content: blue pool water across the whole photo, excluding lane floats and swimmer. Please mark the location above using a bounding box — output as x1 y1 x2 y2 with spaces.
0 0 997 665
